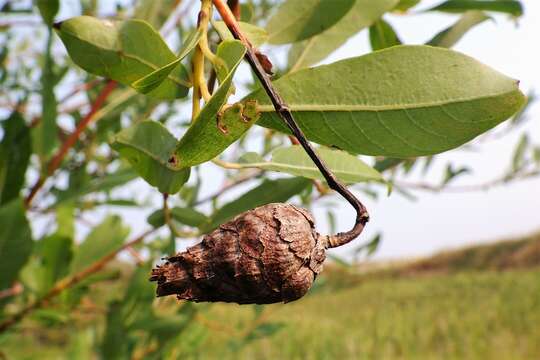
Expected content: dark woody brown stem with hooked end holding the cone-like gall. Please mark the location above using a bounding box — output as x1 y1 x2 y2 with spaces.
212 0 369 248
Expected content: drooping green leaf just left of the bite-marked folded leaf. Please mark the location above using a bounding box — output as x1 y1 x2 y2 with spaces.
111 121 190 194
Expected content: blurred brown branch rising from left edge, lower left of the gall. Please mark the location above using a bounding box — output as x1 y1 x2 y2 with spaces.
0 228 157 334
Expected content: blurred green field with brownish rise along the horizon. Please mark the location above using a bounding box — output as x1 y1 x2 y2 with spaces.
0 237 540 360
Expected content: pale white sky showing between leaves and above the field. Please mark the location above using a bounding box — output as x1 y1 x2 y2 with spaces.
23 0 540 259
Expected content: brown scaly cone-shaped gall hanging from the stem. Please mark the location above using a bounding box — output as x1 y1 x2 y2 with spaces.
150 204 326 304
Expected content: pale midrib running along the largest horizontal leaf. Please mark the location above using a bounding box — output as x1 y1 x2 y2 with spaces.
257 88 519 112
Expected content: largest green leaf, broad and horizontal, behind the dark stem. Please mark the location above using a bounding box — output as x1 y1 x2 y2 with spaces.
250 46 525 157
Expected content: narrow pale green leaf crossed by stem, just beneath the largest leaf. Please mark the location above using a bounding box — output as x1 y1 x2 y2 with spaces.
237 145 384 184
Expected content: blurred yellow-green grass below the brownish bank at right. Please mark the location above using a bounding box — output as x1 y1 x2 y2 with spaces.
201 269 540 360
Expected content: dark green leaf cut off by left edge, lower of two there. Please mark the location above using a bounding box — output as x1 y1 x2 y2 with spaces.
0 199 34 290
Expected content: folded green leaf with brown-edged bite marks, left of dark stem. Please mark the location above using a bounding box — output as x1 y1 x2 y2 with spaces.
173 40 259 169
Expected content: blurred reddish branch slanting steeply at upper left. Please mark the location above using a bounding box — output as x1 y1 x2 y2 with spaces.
24 80 117 207
